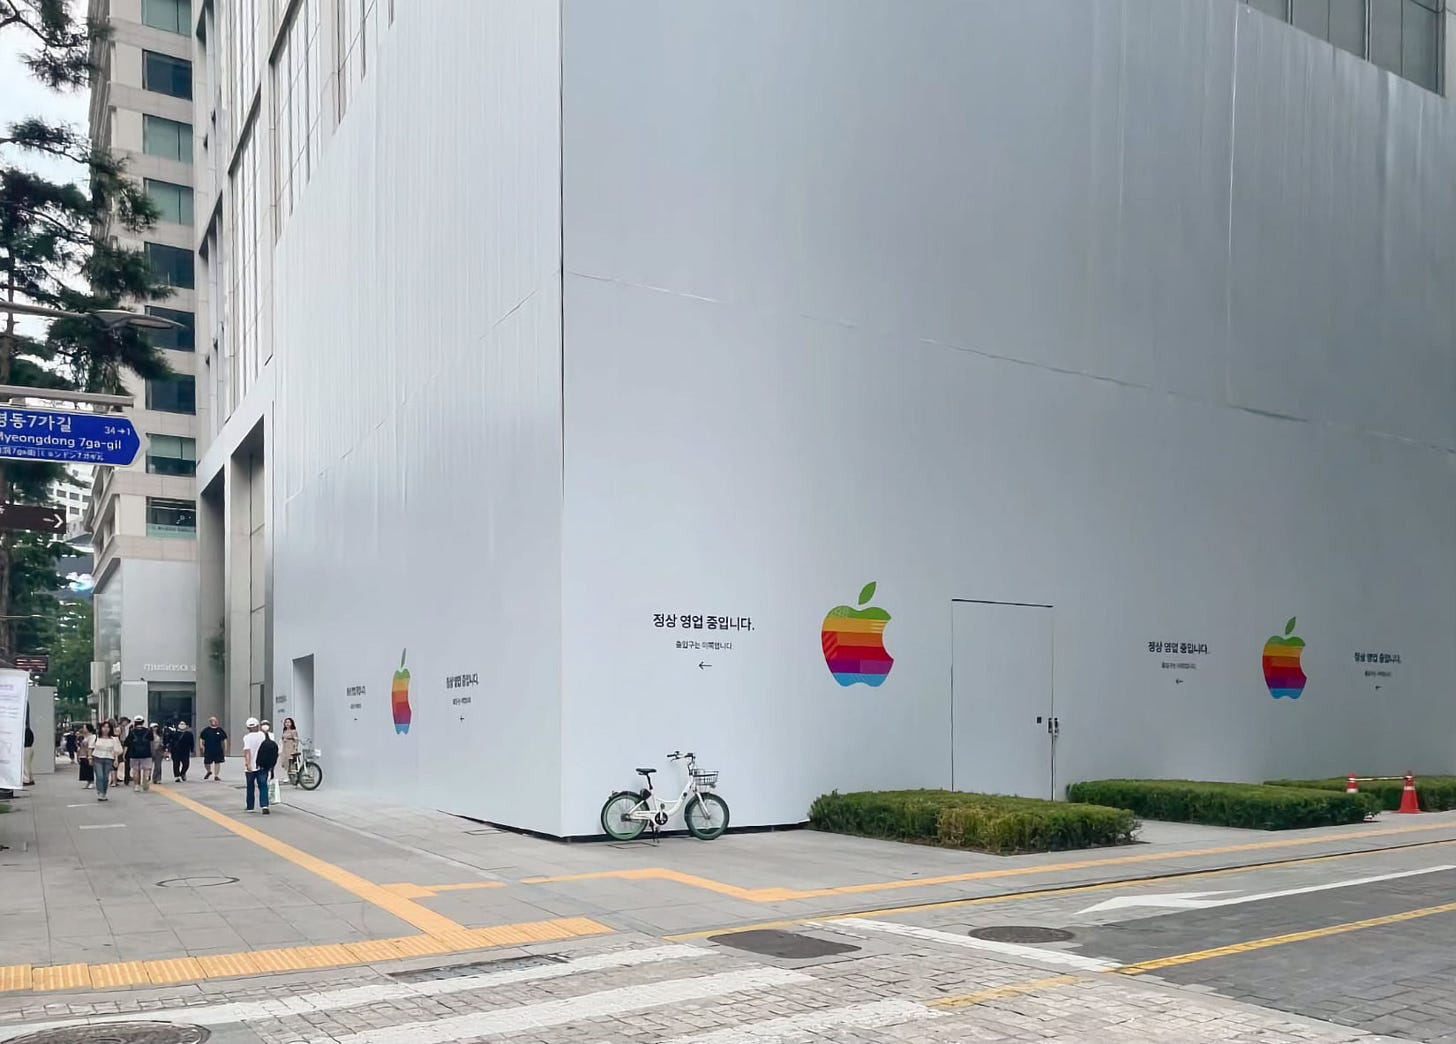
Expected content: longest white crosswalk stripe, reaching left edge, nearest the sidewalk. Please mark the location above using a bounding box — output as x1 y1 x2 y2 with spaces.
0 945 713 1041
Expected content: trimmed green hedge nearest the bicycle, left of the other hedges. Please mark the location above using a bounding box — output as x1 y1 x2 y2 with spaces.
810 791 1139 855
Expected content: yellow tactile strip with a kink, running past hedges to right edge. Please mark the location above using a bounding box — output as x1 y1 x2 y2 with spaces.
535 820 1456 903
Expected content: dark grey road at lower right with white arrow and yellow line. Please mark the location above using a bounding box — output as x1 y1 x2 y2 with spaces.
850 843 1456 1044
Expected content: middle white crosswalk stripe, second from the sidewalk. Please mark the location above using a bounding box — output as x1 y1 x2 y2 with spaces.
310 968 814 1044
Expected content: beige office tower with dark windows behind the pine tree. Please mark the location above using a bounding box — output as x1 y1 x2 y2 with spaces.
86 0 198 721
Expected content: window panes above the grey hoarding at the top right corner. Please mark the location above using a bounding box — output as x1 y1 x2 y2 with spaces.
1243 0 1446 93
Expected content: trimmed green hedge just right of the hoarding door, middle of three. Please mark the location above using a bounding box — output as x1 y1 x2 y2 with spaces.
1067 779 1380 830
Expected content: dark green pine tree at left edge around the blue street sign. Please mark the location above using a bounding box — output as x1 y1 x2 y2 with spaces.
0 0 180 663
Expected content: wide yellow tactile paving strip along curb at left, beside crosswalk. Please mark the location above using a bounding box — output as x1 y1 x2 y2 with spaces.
0 917 612 993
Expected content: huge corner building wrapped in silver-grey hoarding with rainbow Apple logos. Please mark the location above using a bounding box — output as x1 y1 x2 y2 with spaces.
198 0 1456 836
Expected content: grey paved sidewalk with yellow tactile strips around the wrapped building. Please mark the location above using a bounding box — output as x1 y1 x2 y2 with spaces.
0 770 1456 992
